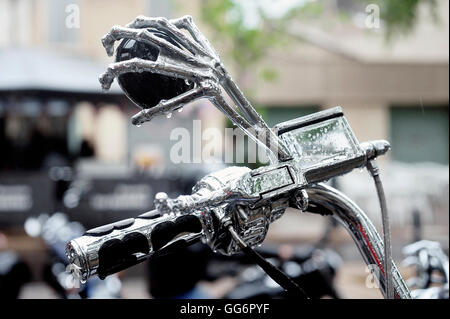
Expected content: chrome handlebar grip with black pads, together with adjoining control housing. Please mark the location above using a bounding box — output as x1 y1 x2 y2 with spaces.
66 167 295 281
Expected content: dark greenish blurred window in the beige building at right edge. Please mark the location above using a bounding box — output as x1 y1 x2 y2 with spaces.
391 106 449 164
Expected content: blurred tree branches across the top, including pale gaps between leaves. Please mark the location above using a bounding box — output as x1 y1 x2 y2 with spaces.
192 0 437 89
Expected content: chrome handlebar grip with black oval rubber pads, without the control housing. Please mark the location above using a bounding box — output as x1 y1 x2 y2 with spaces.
66 210 203 282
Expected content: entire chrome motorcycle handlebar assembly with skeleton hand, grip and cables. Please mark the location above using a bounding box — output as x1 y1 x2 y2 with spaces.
66 16 444 299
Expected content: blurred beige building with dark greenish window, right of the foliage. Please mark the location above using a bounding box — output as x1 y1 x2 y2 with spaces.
257 1 449 164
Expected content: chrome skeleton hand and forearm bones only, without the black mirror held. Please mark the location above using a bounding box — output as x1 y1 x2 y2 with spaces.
99 16 289 162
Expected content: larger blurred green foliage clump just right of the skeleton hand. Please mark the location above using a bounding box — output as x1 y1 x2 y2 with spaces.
200 0 300 90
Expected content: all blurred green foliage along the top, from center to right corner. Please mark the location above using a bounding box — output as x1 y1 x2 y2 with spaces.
200 0 437 77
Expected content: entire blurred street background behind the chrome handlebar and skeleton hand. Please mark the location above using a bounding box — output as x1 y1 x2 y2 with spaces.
0 0 449 298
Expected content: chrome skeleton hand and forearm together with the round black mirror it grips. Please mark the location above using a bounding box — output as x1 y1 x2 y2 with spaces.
100 16 289 160
